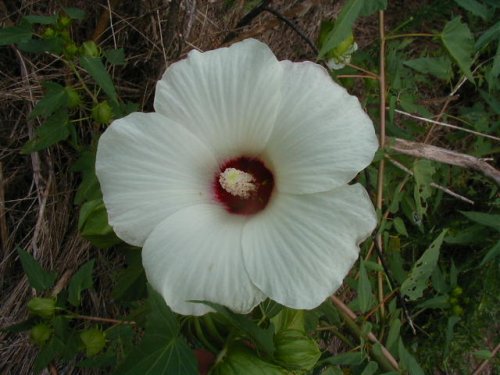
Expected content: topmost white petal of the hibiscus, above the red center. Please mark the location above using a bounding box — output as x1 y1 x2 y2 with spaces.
154 39 282 161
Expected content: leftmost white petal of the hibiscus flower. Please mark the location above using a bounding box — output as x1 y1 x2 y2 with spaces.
96 113 218 246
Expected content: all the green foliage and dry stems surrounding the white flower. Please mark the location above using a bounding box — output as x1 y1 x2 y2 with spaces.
0 0 500 375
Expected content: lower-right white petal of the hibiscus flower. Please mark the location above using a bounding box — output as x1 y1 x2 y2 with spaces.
243 184 376 309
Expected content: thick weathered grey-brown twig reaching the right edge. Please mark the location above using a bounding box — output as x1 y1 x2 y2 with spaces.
389 138 500 185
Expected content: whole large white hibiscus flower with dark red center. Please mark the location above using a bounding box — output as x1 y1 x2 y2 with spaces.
96 39 377 315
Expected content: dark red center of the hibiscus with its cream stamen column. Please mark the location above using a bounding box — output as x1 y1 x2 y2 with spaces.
214 156 274 215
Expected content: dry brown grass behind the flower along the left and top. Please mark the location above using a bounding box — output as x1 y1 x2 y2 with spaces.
0 0 370 374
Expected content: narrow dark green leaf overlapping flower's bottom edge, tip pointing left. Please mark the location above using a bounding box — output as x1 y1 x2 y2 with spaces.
200 301 274 356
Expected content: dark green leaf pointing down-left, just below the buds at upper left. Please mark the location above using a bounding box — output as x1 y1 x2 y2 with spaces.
21 111 70 155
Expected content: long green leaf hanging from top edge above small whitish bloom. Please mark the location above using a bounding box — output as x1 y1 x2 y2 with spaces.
319 0 365 57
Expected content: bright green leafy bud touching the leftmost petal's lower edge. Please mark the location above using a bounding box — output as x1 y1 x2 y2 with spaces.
78 199 121 249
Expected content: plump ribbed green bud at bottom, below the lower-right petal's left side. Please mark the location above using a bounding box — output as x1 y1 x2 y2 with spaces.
274 329 321 370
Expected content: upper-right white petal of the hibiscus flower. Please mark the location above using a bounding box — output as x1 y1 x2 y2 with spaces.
266 61 378 193
